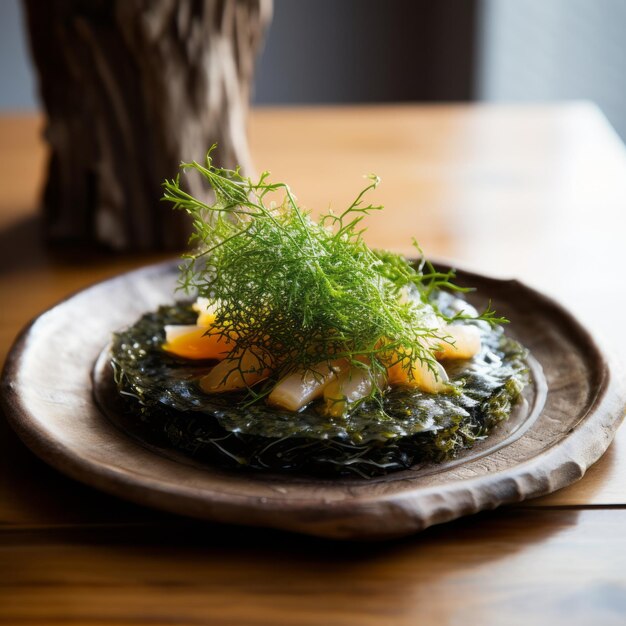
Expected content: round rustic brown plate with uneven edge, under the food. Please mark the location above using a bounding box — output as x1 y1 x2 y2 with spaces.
2 263 626 539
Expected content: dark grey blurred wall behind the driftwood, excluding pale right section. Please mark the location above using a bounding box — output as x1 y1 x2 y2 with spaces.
0 0 476 108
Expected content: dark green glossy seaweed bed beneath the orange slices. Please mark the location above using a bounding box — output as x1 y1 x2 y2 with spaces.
111 292 528 477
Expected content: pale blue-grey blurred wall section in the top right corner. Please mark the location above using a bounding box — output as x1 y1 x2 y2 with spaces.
477 0 626 139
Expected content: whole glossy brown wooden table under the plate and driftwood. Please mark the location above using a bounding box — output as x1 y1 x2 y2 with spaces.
0 103 626 626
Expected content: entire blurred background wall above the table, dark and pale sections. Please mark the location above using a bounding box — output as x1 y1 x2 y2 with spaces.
0 0 626 139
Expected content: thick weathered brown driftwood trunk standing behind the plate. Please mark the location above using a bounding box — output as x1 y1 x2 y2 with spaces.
24 0 272 250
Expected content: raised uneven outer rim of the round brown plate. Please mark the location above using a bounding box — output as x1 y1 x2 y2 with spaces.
2 261 626 538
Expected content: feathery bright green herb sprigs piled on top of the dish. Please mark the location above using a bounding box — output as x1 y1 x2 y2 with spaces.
164 146 503 398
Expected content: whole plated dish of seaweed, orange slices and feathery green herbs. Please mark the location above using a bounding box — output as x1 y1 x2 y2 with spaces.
111 151 528 478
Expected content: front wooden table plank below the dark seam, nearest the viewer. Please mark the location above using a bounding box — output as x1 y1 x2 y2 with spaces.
0 509 626 626
